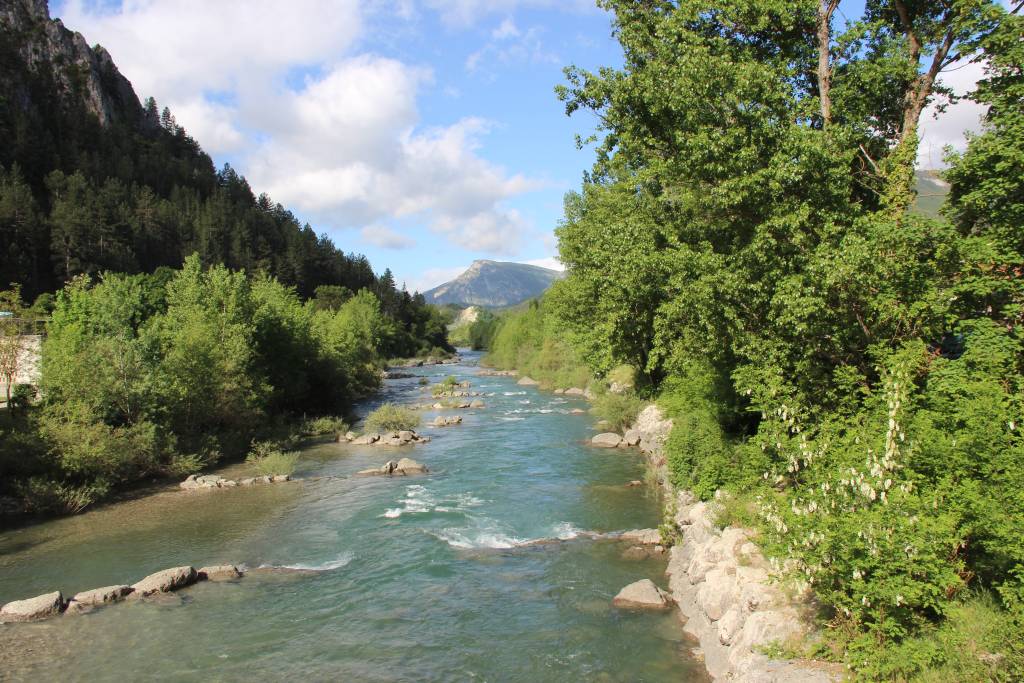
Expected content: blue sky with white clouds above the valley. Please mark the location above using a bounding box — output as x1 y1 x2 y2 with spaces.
51 0 980 291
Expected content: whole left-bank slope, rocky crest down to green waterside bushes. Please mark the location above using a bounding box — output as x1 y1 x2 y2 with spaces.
0 0 453 514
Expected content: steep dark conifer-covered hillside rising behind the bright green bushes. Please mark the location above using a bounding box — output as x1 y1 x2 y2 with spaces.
0 0 393 305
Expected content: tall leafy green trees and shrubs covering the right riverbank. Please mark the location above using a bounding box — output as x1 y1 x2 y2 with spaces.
477 0 1024 681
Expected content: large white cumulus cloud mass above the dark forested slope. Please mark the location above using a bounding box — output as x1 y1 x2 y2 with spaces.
59 0 539 255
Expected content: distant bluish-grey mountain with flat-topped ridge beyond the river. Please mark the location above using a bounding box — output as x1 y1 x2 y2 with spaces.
423 260 562 308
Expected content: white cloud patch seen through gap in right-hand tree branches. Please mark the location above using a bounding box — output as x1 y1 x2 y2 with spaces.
918 63 986 168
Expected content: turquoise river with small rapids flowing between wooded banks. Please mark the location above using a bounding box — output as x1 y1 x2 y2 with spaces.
0 353 707 682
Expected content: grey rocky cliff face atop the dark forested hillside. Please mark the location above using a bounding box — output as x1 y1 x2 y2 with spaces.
0 0 145 126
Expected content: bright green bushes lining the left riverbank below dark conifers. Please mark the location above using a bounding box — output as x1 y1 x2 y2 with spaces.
0 256 445 512
